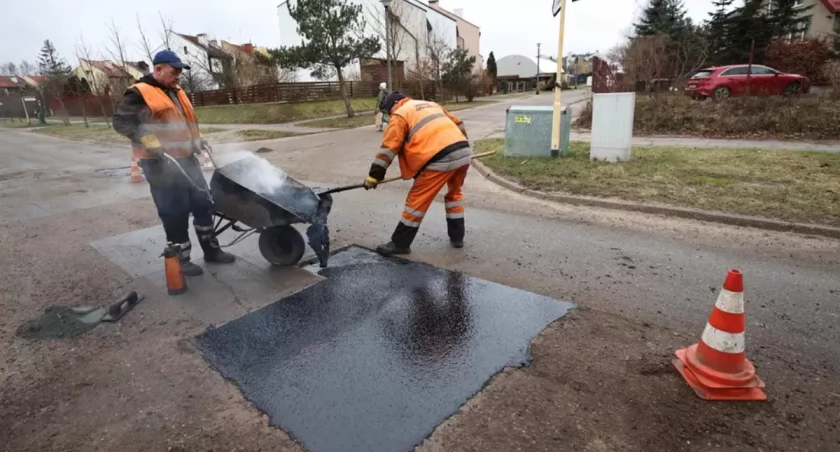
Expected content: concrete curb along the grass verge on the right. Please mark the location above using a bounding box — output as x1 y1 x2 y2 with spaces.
472 159 840 238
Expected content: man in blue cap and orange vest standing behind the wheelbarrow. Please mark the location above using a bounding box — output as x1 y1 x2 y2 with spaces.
113 50 235 276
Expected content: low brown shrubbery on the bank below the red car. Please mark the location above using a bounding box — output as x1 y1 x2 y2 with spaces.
575 93 840 140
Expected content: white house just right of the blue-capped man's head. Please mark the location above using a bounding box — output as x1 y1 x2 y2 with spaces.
155 31 234 92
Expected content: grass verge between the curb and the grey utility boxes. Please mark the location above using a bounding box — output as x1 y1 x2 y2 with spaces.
475 139 840 226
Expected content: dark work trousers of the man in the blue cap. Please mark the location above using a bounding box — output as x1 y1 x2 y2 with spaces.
140 156 214 260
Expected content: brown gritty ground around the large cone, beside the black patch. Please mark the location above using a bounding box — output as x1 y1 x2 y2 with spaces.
419 308 840 452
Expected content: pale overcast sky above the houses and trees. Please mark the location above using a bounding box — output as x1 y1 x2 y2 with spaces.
0 0 712 67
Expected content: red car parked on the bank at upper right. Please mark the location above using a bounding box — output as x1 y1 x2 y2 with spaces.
685 64 811 99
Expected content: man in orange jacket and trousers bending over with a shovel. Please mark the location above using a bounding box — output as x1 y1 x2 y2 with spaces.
364 92 472 256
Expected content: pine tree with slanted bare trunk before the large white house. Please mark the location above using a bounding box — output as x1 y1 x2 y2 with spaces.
270 0 381 117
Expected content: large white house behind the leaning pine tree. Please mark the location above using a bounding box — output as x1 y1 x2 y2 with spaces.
277 0 460 83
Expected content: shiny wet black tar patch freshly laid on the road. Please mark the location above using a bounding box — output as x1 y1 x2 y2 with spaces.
195 247 573 452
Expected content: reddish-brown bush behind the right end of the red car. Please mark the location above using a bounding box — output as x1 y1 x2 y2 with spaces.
764 39 830 83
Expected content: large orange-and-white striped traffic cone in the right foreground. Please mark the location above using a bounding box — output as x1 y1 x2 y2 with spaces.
673 270 767 400
